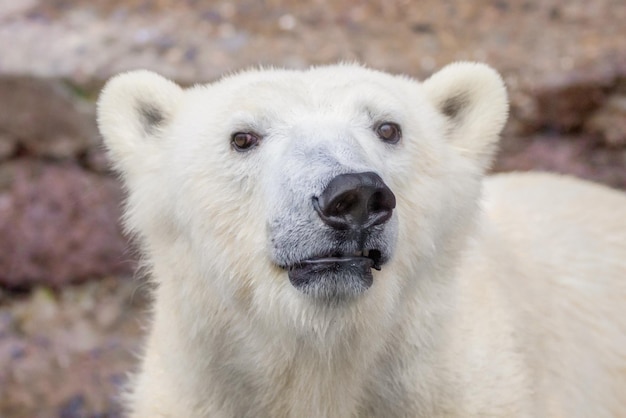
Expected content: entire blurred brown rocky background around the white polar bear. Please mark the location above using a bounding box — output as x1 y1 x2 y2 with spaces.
0 0 626 418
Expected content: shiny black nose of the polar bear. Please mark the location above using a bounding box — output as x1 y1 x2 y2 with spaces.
313 173 396 229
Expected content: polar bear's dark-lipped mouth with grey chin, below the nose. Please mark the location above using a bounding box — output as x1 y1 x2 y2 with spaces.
286 249 383 299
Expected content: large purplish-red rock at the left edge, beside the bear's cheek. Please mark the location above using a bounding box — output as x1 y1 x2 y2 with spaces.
0 159 132 287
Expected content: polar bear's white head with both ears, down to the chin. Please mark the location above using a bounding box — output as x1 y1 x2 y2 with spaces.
98 63 507 326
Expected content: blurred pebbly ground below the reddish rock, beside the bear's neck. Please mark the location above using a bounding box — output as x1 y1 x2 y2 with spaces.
0 278 146 418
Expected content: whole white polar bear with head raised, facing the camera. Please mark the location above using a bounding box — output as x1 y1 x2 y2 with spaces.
98 63 626 418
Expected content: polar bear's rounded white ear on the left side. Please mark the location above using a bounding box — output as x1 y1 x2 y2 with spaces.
98 70 183 173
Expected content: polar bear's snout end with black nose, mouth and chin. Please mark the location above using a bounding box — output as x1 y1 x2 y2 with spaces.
273 171 397 303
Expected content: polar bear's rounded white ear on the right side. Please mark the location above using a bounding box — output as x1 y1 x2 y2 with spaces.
423 62 509 169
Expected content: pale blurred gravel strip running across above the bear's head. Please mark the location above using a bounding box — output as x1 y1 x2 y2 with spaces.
0 0 626 84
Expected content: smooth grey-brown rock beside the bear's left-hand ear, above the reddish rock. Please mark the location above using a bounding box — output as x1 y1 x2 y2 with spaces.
0 77 97 159
